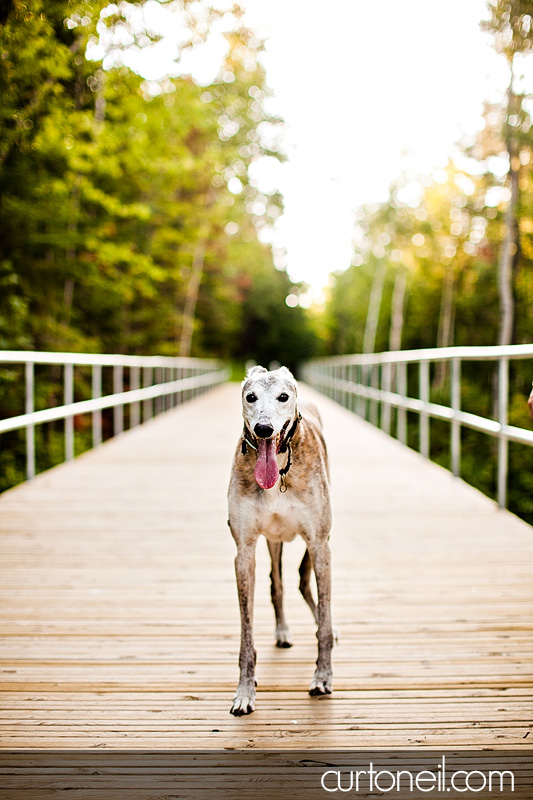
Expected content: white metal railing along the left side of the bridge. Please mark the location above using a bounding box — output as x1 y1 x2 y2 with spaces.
0 350 229 479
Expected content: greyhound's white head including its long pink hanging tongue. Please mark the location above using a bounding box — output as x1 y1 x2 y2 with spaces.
242 367 298 489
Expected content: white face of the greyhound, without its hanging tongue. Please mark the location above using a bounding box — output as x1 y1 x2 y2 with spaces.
242 367 296 439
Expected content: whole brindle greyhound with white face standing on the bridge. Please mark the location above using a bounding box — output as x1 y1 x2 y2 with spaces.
228 367 333 716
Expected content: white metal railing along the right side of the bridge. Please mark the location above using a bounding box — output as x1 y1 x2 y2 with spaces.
301 344 533 508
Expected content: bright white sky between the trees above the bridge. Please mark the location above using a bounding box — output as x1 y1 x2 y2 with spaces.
100 0 507 290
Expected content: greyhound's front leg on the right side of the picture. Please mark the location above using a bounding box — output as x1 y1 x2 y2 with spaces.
308 541 333 695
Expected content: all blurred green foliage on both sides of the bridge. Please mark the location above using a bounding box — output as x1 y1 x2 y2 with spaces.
0 0 533 522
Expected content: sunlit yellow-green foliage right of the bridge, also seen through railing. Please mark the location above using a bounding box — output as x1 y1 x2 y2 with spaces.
318 6 533 522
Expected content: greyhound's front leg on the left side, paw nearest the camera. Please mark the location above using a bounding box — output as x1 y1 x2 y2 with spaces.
231 540 256 717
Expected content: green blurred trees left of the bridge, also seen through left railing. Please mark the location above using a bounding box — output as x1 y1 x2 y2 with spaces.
0 0 314 488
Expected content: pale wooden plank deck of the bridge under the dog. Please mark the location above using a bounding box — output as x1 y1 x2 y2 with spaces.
0 385 533 756
